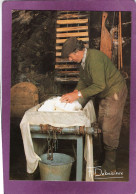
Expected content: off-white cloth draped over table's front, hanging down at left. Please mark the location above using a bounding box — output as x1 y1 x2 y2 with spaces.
20 101 96 180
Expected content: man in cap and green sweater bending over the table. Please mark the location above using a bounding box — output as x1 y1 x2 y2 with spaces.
61 37 127 172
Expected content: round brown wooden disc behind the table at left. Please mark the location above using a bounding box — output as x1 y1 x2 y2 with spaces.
11 82 39 118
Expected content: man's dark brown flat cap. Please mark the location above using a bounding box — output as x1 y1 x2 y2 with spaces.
61 37 78 58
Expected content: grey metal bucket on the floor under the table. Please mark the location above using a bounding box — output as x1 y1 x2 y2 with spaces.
39 153 74 181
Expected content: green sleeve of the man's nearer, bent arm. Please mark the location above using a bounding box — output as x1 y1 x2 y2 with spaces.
80 63 106 98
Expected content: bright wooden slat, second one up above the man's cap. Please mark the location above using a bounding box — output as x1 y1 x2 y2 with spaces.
56 26 88 32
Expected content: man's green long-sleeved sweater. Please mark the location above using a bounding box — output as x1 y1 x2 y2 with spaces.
76 49 125 98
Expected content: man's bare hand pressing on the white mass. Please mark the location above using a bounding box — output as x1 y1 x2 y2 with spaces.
60 90 79 103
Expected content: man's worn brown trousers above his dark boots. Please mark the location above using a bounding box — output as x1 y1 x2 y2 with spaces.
98 85 128 149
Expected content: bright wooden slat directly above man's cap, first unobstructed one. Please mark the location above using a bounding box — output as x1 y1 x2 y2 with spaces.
56 32 88 38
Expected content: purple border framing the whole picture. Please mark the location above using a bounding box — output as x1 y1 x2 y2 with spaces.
2 0 136 194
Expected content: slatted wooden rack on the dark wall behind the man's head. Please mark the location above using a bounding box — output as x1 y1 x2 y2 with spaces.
55 11 89 83
